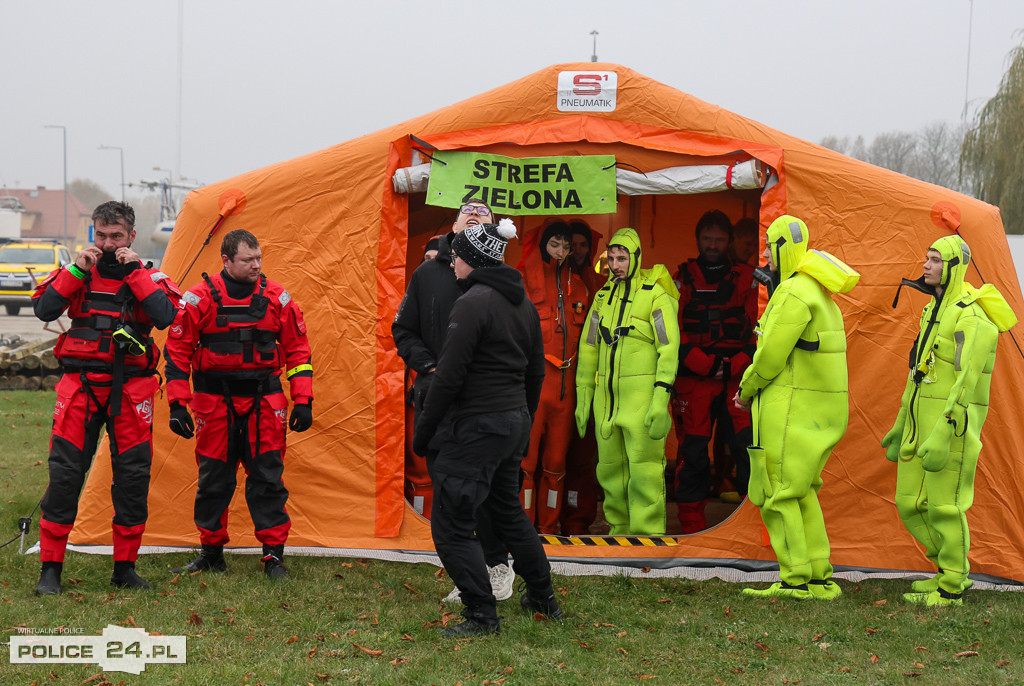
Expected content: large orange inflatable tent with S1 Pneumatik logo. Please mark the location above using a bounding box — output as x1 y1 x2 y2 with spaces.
72 63 1024 582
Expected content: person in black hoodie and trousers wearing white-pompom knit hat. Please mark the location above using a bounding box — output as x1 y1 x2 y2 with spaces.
413 219 562 638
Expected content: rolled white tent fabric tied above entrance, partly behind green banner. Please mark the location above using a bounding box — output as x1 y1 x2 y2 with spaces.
391 160 765 196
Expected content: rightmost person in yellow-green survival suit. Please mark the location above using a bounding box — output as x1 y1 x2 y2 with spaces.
882 235 1017 606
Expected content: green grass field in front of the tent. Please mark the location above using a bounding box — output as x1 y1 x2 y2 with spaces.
0 391 1024 686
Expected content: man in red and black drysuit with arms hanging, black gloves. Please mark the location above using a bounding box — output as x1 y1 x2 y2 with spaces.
165 229 313 580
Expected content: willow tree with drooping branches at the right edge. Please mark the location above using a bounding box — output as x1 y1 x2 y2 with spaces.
961 45 1024 233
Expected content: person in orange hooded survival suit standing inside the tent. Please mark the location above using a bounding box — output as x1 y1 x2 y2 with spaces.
516 221 590 533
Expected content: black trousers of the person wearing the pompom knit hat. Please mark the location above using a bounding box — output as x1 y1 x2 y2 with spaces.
430 408 552 619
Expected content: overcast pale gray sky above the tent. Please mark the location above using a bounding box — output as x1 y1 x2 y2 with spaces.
0 0 1024 197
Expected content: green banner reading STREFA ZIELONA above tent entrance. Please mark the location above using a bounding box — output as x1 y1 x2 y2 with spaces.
427 151 615 215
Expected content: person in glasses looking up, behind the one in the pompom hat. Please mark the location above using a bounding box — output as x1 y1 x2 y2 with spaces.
391 199 515 603
